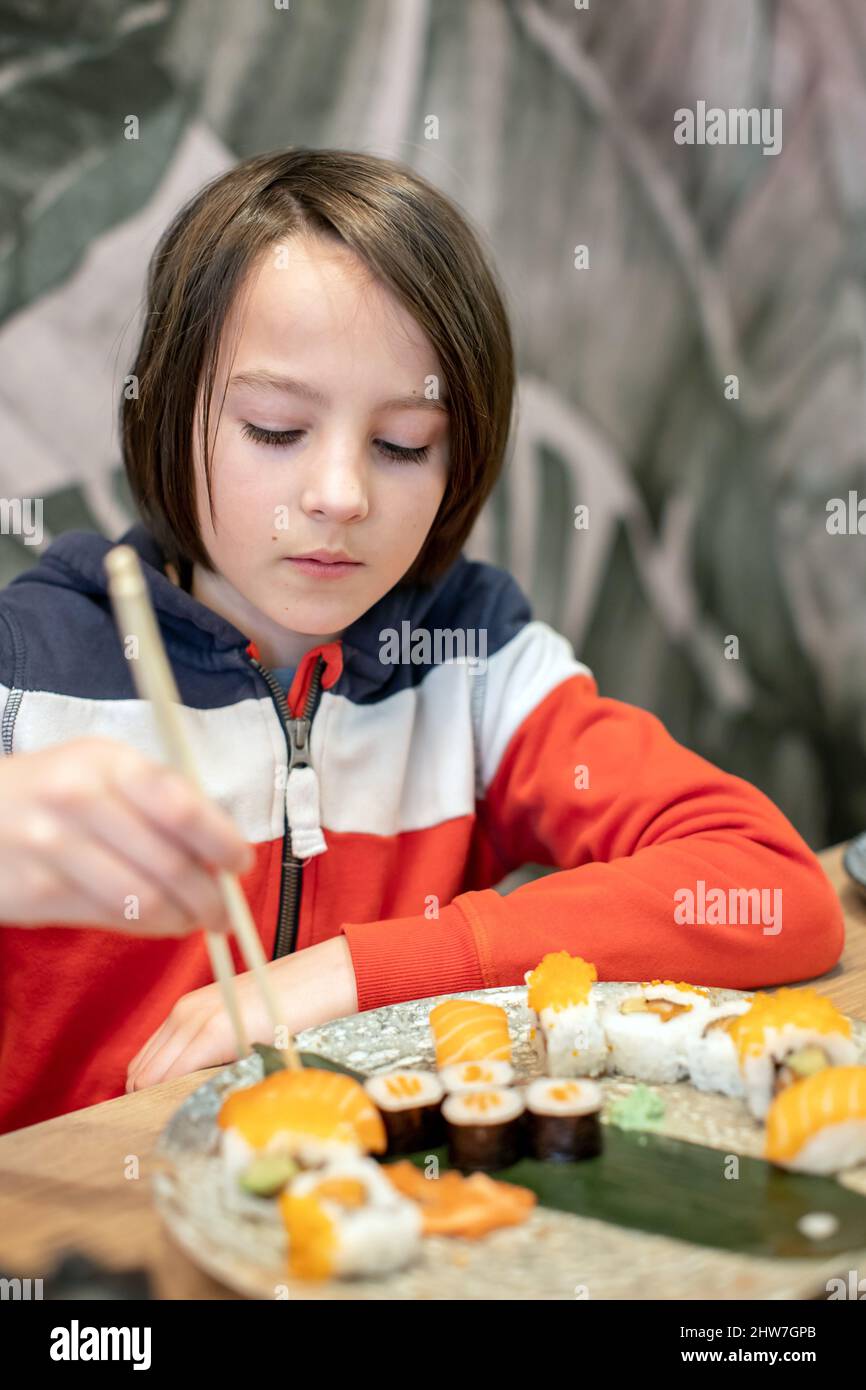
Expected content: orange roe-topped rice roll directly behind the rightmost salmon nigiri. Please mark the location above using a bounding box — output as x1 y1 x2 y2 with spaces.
728 988 858 1120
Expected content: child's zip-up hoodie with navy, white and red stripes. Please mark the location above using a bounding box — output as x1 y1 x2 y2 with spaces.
0 524 842 1130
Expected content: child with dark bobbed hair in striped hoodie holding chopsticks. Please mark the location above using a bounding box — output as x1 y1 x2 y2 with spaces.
0 149 842 1129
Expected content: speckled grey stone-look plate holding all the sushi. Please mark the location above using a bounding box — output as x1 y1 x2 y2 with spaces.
153 981 866 1300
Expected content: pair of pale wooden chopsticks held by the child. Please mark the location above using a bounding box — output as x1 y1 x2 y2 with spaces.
104 545 302 1068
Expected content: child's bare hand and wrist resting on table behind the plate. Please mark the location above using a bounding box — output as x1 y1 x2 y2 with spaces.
126 935 357 1091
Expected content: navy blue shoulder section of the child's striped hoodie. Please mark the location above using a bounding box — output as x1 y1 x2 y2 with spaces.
0 523 530 733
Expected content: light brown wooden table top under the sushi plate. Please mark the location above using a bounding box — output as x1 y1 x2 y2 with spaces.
0 847 866 1298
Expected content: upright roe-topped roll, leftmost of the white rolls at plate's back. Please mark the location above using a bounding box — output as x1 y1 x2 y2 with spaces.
527 951 607 1076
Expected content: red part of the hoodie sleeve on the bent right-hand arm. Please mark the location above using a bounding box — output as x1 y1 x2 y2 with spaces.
341 674 844 1009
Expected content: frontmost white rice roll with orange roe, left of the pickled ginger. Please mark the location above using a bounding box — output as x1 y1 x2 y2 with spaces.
279 1154 423 1280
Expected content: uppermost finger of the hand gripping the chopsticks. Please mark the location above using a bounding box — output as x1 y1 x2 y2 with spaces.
111 751 252 873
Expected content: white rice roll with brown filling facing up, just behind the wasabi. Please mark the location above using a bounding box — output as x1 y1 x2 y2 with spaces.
602 980 710 1083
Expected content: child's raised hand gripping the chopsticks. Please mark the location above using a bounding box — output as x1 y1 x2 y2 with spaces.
0 738 252 937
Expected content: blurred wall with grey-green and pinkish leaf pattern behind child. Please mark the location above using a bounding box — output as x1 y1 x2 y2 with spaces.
0 0 866 847
